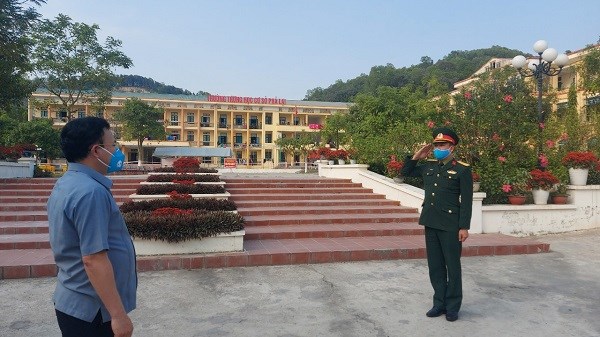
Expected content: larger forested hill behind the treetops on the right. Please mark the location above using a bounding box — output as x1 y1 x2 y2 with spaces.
304 46 525 102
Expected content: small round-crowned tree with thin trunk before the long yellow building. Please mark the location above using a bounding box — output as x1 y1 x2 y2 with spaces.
114 98 165 166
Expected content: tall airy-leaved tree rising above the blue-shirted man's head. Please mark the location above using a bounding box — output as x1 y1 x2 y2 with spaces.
32 14 132 119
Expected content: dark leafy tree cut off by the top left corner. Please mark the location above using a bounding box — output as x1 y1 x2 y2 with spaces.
0 0 45 112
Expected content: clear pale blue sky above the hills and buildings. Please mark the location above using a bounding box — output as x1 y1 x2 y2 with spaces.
37 0 600 100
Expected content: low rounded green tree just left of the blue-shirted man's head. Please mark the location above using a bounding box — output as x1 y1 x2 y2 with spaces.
7 119 62 159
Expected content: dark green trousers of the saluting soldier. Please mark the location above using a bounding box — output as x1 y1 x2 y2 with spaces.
425 227 462 312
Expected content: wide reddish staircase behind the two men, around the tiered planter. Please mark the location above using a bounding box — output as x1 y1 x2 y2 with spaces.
0 175 549 279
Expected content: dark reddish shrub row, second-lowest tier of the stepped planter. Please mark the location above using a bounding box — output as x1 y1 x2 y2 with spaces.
121 198 237 213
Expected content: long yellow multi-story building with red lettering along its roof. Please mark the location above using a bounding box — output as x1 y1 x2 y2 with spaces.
28 90 349 167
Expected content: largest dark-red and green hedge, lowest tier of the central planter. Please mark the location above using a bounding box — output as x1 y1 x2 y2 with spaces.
123 211 244 242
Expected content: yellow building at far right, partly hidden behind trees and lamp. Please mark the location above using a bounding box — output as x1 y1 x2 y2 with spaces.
452 45 600 121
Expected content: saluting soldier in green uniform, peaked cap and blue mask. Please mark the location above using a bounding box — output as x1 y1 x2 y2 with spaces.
402 128 473 322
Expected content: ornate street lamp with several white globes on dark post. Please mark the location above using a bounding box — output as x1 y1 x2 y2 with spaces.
512 40 569 166
